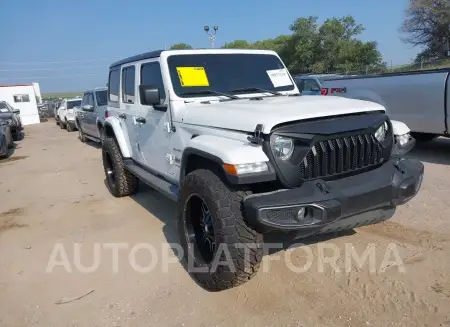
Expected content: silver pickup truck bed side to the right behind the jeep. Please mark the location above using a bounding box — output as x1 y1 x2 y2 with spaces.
319 68 450 141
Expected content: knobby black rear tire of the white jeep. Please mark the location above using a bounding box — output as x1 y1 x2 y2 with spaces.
102 137 138 198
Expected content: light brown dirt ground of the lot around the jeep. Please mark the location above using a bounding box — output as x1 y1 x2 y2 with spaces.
0 121 450 327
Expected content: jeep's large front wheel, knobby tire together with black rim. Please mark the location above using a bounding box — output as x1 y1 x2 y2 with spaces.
178 169 263 291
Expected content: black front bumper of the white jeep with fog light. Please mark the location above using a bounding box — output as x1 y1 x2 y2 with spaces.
244 158 424 234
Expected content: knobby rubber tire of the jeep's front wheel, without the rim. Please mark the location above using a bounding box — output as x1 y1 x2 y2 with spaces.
177 169 263 291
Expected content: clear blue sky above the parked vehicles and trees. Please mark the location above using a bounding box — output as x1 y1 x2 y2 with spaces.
0 0 420 93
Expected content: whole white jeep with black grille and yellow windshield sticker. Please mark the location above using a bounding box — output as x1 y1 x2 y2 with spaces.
102 49 424 291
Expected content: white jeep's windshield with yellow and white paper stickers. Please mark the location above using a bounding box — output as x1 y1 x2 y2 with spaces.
167 53 294 98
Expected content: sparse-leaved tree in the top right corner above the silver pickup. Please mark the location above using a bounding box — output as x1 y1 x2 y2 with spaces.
400 0 450 61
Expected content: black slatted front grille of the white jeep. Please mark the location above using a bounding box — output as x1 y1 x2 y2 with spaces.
300 133 384 180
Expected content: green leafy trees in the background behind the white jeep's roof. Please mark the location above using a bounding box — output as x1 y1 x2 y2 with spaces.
172 16 385 74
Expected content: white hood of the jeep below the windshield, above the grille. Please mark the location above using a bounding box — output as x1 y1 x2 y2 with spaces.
181 95 385 134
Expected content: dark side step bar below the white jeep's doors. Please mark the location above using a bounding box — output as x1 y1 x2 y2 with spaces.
124 160 178 202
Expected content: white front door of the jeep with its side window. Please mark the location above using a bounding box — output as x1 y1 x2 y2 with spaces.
136 59 174 179
